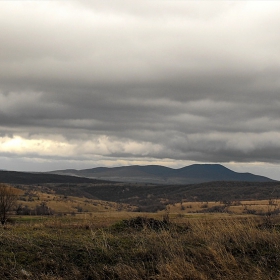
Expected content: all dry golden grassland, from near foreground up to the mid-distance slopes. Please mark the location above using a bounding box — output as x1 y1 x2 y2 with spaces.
0 185 280 280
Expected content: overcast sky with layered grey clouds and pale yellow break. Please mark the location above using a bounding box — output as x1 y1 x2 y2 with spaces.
0 0 280 180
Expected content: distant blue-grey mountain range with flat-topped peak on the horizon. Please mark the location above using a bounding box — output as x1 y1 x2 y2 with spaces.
51 164 274 184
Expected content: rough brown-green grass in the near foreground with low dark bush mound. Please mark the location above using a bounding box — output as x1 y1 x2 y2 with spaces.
0 214 280 280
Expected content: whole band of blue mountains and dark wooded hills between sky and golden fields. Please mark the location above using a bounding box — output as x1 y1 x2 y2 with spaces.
0 164 280 211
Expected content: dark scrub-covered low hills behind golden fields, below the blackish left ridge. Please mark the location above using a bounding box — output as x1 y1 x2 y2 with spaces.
7 179 280 212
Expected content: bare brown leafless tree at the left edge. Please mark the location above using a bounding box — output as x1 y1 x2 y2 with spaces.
0 183 20 225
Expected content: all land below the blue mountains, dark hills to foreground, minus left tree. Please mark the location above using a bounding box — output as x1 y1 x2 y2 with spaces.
0 165 280 280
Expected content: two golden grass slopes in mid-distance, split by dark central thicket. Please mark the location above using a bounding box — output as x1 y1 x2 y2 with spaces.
15 186 280 215
